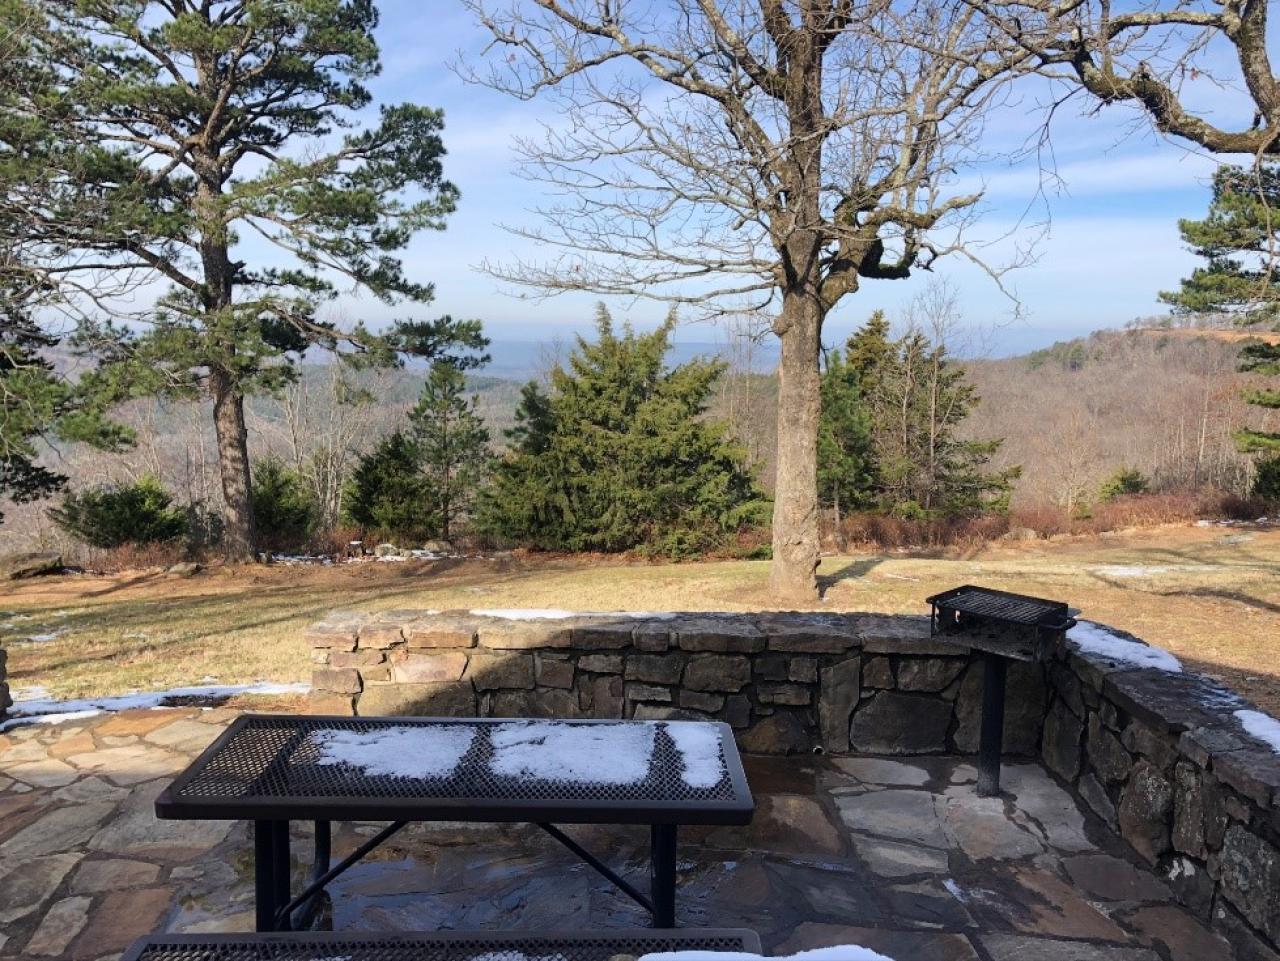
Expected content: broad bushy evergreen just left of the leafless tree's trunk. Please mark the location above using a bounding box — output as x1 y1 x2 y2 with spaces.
477 300 768 557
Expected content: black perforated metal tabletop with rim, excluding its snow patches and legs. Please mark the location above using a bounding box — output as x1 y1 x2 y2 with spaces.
156 714 755 824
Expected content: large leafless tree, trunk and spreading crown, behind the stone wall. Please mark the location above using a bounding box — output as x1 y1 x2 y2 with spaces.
466 0 1037 596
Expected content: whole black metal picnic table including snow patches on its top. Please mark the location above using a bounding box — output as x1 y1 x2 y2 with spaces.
155 714 755 932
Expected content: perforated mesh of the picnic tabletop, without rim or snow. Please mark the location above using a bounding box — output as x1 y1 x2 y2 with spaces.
175 717 736 804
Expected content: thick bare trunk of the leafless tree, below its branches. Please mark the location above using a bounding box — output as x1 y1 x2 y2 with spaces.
769 292 823 601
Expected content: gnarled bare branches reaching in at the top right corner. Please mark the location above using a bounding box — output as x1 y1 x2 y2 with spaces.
988 0 1280 156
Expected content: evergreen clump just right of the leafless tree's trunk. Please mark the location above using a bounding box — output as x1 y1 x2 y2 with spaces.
818 311 1020 520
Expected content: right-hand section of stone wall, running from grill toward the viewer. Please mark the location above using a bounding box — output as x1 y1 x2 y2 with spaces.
1043 632 1280 961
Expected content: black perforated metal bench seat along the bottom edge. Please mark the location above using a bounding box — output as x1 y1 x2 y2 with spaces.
120 929 760 961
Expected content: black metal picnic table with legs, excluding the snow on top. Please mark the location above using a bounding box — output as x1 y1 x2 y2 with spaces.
155 714 755 932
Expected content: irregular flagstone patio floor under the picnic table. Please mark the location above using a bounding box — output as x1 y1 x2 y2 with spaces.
0 709 1245 961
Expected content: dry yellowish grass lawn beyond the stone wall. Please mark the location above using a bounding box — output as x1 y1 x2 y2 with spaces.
0 527 1280 713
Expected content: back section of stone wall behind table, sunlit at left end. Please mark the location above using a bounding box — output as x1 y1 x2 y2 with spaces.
308 610 1046 755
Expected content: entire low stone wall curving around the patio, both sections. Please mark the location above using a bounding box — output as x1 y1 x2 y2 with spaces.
307 610 1280 961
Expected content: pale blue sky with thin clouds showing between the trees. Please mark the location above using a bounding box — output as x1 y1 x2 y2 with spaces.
330 0 1239 356
